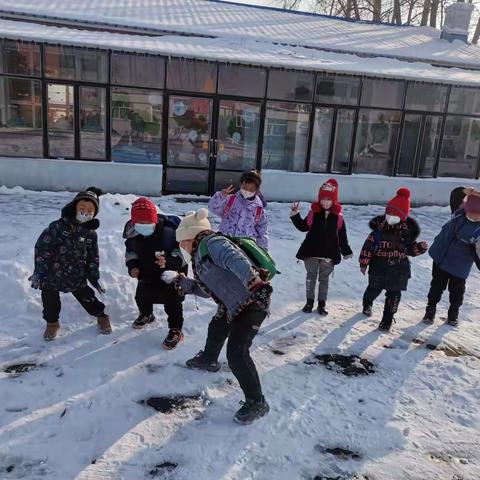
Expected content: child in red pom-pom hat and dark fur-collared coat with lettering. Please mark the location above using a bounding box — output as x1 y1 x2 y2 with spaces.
360 188 428 331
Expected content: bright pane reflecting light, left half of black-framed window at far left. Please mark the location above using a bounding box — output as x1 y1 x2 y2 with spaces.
47 83 75 158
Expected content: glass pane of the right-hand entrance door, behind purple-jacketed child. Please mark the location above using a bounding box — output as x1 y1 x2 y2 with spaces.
216 100 260 170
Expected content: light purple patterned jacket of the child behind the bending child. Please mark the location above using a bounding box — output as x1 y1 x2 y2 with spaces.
208 192 268 250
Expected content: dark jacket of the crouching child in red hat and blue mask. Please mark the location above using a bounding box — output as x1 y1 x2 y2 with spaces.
123 214 188 287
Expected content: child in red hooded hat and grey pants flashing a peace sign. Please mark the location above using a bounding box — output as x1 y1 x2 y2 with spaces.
290 178 352 315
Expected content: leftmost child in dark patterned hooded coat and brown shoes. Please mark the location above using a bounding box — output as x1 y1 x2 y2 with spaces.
29 187 112 340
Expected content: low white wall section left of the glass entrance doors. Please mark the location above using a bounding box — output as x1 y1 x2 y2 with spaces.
0 158 162 195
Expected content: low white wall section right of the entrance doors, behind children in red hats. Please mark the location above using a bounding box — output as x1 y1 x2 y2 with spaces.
262 170 480 205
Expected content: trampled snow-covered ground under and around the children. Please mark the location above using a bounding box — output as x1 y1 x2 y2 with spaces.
0 188 480 480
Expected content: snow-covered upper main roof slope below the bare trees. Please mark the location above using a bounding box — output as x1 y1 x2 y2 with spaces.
0 0 480 68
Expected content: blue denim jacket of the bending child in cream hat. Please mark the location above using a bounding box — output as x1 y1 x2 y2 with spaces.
180 235 264 321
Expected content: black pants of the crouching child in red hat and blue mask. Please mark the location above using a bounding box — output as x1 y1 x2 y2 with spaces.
135 282 183 330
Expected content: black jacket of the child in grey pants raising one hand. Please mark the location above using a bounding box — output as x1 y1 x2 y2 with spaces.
290 210 353 265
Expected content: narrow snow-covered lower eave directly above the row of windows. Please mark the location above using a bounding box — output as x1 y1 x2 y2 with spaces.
0 20 480 86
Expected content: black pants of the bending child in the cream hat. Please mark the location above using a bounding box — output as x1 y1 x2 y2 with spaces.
203 304 267 401
